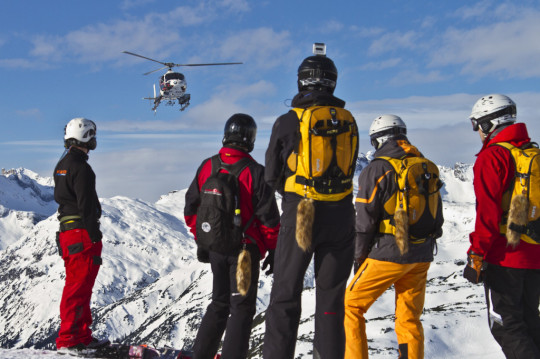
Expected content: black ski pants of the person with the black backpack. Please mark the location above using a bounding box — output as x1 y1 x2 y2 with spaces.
193 244 261 359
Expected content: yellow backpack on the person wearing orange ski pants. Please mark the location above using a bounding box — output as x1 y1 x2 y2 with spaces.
376 156 443 254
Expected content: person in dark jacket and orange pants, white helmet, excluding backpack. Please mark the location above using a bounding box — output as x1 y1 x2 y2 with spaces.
344 115 443 359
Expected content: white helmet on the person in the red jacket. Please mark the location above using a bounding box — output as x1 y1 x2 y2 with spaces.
469 94 516 135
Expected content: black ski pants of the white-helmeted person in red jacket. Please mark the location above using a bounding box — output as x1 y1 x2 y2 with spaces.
484 264 540 359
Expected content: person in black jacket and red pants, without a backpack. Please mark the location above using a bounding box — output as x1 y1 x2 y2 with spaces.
53 118 108 355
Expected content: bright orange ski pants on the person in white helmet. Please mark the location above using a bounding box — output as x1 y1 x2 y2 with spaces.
344 258 430 359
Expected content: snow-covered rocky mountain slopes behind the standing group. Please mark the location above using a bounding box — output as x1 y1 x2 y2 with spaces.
0 161 504 358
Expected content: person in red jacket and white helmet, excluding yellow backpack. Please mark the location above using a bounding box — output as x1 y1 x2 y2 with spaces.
463 94 540 359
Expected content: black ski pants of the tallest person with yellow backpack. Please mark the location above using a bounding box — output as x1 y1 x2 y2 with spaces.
263 201 355 359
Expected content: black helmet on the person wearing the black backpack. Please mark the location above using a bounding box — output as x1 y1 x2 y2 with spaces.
223 113 257 152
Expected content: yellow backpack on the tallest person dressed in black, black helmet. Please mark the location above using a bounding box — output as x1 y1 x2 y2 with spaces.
285 106 358 201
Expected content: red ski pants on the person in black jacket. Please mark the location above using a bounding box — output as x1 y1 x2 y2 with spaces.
56 229 102 348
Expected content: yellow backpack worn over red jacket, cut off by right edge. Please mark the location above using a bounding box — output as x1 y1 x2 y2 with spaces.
495 142 540 247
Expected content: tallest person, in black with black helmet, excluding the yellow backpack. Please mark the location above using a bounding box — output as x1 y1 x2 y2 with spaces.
263 44 356 359
